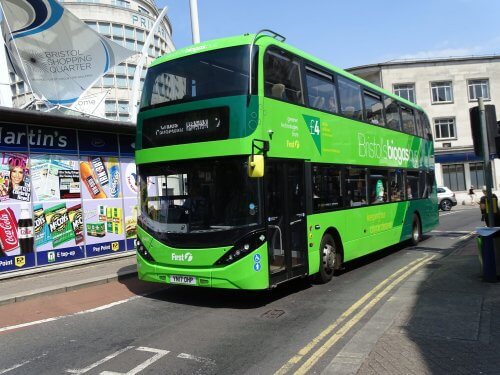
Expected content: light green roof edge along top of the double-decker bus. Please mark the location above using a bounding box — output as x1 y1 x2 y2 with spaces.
150 34 423 110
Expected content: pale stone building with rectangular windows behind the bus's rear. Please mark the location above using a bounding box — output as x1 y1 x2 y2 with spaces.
347 55 500 200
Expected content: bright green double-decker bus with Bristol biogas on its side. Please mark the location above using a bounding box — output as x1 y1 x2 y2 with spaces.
136 30 439 290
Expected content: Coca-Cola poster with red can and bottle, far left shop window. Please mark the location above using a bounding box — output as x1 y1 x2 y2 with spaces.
0 202 35 273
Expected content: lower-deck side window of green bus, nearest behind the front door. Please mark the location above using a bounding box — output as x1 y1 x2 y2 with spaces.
312 164 343 212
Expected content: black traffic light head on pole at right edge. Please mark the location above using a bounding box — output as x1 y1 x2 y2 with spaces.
469 104 500 158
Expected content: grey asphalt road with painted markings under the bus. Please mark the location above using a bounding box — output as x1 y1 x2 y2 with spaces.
0 205 482 375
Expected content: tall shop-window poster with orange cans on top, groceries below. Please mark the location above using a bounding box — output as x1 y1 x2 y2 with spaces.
80 156 126 257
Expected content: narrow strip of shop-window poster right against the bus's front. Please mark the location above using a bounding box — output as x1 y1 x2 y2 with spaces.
121 158 138 250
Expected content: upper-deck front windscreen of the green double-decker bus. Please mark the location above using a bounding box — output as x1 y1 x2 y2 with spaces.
141 45 257 108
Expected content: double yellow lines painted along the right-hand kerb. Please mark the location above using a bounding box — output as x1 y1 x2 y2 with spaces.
275 255 436 375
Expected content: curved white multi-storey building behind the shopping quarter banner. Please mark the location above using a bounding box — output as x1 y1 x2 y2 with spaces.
10 0 175 122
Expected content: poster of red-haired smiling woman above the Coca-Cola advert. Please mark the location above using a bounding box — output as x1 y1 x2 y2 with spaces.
0 152 31 202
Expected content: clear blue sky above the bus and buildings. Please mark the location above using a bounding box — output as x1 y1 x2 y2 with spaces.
156 0 500 69
